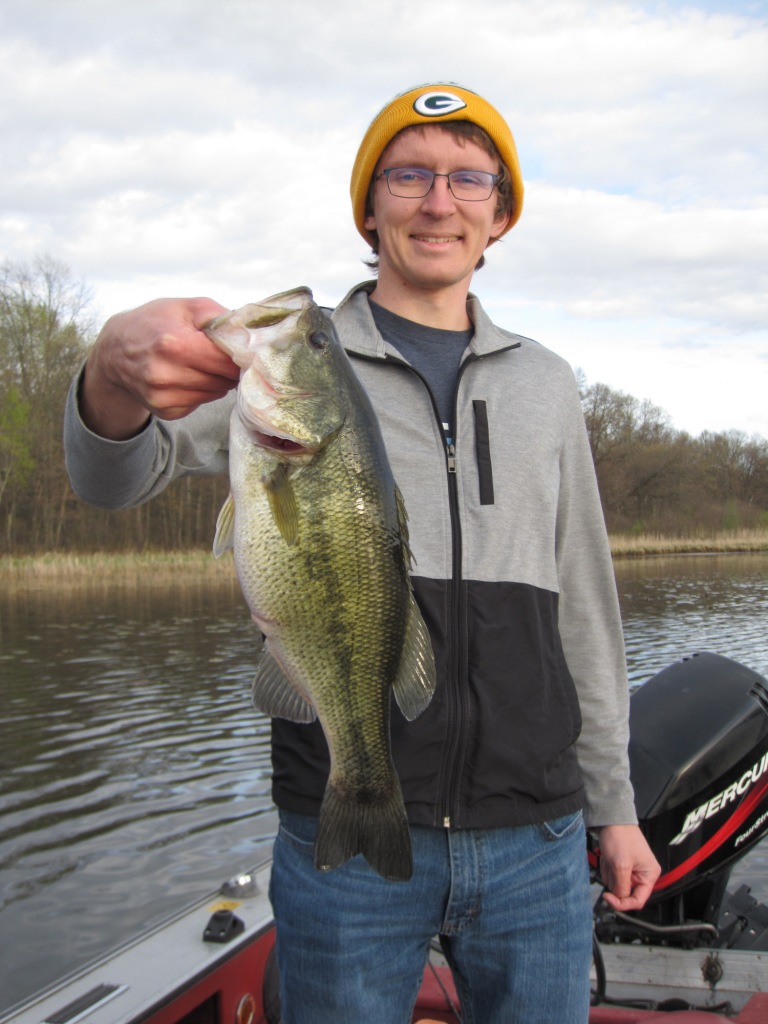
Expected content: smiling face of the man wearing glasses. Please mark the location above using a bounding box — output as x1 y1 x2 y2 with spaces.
366 125 508 299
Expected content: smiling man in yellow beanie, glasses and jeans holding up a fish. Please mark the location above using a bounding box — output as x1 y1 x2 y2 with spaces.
66 84 659 1024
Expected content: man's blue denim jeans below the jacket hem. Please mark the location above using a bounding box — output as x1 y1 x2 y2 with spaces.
270 812 592 1024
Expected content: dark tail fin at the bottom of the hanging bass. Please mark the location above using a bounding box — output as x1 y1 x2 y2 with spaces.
314 776 414 882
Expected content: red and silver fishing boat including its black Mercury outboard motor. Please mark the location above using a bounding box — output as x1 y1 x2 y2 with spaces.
0 653 768 1024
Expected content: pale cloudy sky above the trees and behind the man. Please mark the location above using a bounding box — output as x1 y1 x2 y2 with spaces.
0 0 768 438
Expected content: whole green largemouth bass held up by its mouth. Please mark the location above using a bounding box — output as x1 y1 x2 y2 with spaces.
205 288 435 880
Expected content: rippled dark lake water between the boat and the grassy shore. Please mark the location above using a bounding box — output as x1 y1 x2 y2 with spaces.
0 555 768 1012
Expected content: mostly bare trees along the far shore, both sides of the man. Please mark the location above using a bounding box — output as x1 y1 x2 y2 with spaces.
0 256 768 554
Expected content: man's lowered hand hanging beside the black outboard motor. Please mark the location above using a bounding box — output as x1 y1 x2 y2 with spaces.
599 825 662 911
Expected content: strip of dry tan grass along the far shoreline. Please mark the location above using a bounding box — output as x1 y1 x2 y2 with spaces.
0 529 768 586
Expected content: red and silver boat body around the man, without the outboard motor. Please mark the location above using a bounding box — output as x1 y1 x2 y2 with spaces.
0 864 768 1024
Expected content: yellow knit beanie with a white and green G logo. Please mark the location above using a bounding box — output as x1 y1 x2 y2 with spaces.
349 83 523 243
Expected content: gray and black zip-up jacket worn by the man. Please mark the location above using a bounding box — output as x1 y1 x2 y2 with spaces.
65 283 636 827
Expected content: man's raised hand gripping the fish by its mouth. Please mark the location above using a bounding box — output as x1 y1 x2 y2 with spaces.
80 299 240 440
